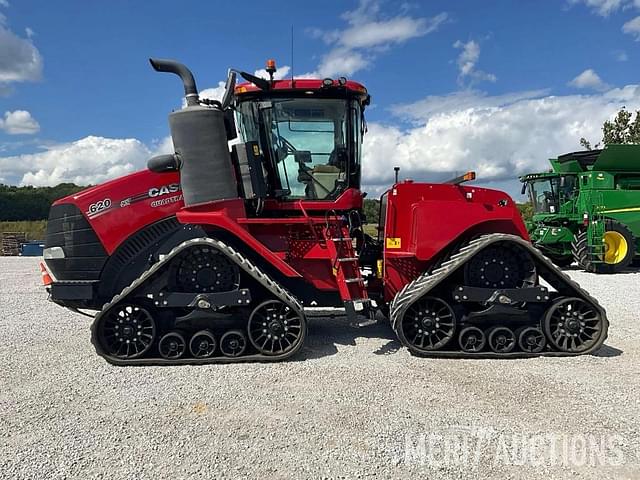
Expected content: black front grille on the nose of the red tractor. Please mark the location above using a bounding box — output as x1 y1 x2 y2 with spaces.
45 203 108 280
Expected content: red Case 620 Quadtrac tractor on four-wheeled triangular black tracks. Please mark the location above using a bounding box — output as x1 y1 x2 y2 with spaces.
43 60 608 365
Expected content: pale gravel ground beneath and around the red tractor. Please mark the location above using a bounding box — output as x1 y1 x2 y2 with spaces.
0 257 640 479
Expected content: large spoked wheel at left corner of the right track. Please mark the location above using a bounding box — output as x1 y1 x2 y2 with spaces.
398 297 456 353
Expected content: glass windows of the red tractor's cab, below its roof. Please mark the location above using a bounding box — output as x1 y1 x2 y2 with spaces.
238 98 361 199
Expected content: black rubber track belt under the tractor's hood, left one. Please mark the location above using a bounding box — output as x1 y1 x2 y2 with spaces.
91 238 306 366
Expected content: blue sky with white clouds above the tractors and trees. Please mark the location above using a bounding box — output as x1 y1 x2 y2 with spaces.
0 0 640 199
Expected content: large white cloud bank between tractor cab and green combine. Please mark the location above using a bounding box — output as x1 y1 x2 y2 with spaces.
363 85 640 194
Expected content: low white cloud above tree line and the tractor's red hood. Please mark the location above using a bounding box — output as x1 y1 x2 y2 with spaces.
0 136 152 186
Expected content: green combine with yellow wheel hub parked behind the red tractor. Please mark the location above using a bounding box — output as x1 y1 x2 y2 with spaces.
520 144 640 273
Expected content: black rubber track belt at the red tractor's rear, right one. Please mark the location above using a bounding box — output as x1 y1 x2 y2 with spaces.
389 233 609 358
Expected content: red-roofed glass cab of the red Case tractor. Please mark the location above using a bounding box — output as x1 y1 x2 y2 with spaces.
230 63 369 201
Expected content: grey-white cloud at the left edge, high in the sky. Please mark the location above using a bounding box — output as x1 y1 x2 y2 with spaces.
0 19 42 84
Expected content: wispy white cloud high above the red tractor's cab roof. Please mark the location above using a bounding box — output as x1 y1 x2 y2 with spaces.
305 0 448 77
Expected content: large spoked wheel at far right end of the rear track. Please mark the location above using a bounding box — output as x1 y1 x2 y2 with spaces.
544 297 603 353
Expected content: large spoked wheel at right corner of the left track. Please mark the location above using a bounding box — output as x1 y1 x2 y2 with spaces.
247 300 306 356
